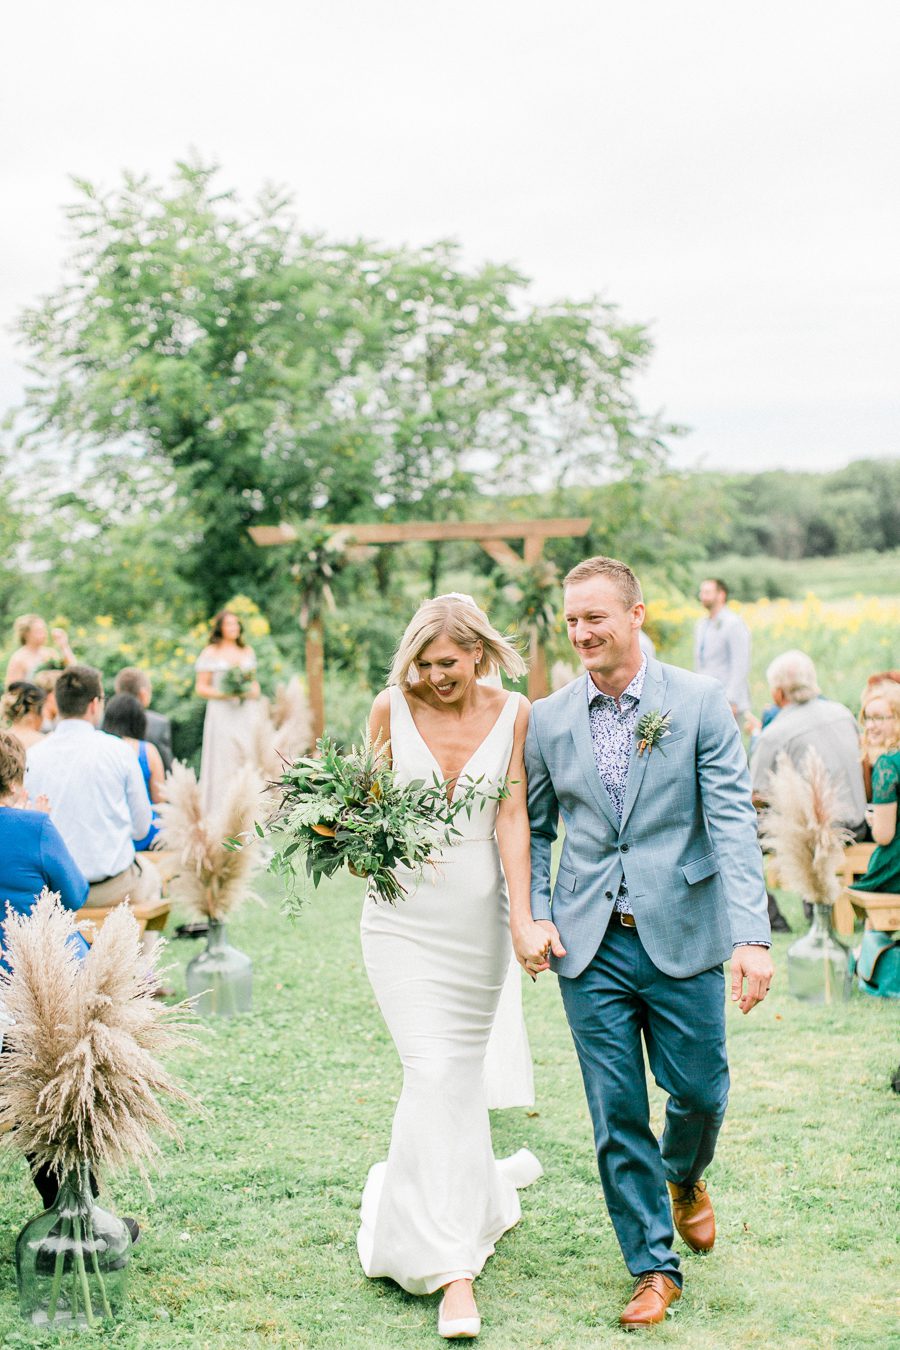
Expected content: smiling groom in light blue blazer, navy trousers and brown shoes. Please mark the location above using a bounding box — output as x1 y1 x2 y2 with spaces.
510 558 772 1327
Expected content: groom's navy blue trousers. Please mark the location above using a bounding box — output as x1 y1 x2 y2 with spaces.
560 914 729 1284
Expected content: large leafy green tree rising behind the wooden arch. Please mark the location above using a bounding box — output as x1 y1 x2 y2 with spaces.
20 154 664 605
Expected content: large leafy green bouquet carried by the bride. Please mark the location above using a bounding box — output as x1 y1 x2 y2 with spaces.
264 736 506 905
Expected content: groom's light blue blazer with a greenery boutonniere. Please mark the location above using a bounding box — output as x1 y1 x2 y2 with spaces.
525 660 770 979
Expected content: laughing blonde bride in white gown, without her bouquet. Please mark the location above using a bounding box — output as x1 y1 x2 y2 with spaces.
358 595 541 1339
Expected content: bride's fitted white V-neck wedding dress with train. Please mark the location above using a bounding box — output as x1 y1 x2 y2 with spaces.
356 687 541 1295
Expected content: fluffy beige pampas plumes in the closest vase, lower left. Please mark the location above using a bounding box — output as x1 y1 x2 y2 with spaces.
0 890 197 1181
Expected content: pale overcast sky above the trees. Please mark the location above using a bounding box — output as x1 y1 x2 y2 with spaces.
0 0 900 468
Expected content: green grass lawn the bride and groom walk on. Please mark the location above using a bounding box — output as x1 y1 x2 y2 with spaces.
0 880 900 1350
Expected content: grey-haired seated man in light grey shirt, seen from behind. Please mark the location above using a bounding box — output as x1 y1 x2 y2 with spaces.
750 651 866 838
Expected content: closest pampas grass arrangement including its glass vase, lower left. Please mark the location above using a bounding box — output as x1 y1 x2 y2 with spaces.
0 891 197 1327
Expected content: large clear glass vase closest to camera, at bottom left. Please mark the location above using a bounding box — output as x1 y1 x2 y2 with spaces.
16 1164 131 1327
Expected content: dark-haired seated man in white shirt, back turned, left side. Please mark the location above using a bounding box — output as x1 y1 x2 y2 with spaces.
26 666 161 909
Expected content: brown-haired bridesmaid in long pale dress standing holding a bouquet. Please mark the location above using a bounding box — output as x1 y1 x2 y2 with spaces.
194 609 259 811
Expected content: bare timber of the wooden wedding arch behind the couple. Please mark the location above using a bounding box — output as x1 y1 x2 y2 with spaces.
250 516 591 738
